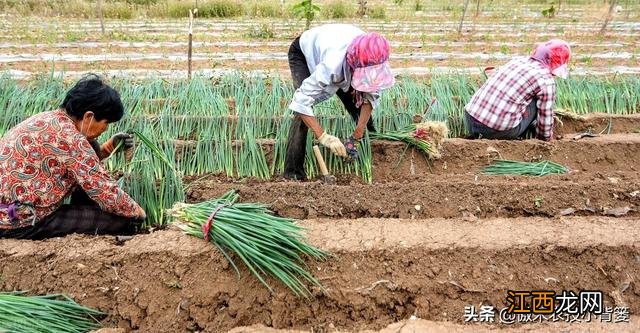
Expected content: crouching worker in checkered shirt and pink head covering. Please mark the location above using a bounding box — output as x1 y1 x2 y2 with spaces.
465 39 571 141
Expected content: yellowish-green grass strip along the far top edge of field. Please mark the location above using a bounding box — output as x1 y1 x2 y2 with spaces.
0 0 637 19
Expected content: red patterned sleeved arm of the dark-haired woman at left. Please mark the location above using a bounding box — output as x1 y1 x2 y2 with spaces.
64 139 146 219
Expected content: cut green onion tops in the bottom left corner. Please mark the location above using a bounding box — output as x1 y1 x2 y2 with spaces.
0 292 102 333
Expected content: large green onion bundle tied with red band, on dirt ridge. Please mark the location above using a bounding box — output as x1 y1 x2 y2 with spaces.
171 190 327 297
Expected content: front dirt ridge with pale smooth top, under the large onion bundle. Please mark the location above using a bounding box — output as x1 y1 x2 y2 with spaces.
0 217 640 332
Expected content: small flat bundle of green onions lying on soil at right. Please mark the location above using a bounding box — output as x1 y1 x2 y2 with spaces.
483 160 569 177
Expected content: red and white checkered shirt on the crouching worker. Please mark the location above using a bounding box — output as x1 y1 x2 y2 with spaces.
465 58 556 140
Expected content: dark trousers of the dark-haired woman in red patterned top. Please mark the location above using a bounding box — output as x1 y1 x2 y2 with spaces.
0 189 142 240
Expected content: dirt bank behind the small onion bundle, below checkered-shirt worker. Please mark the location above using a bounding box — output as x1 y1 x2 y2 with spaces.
372 134 640 182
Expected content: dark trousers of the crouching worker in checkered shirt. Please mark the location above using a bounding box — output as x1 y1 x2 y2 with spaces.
465 99 538 140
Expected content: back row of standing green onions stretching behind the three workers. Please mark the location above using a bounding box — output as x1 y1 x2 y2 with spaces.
0 72 640 136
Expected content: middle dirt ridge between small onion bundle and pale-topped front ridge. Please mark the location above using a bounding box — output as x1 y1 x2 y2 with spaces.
188 174 640 219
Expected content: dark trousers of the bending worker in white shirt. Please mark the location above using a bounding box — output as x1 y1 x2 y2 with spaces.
283 37 375 180
